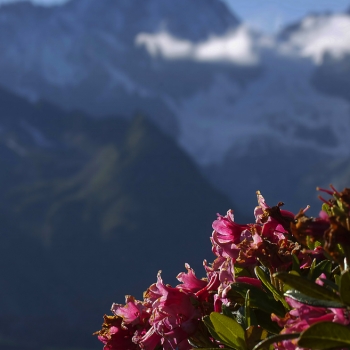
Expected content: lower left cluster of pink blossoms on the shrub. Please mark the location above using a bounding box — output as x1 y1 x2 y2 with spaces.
98 265 212 350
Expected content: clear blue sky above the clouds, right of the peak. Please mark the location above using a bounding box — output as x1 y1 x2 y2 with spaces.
0 0 350 33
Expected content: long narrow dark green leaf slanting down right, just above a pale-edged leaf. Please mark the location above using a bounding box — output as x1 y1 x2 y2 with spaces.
274 272 341 302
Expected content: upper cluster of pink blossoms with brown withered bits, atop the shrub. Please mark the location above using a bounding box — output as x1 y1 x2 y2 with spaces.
211 192 309 270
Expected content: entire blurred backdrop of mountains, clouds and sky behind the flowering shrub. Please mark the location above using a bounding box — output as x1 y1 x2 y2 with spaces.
0 0 350 350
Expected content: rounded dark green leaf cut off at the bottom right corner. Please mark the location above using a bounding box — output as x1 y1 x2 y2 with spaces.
298 322 350 350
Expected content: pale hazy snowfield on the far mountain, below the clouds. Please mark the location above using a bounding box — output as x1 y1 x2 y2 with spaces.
176 49 350 165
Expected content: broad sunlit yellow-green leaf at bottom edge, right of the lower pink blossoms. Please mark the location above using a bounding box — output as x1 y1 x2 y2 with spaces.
210 312 246 350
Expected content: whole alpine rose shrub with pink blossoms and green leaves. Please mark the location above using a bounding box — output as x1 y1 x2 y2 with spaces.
95 186 350 350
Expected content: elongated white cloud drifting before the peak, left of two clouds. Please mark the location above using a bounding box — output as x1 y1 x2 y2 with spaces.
135 26 259 65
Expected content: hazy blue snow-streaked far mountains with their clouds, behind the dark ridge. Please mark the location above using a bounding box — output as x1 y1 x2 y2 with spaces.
0 0 350 213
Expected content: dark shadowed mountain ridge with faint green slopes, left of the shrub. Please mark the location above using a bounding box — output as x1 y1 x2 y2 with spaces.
0 90 232 349
